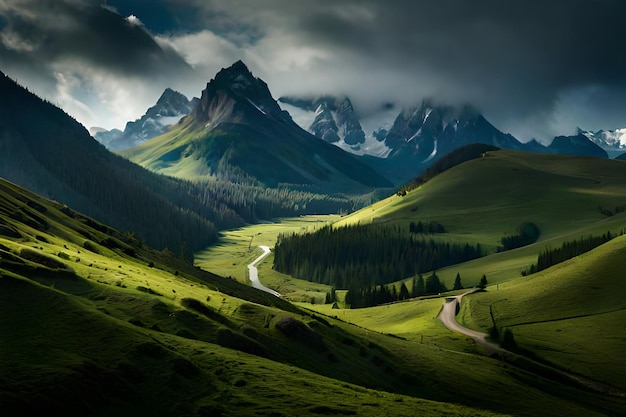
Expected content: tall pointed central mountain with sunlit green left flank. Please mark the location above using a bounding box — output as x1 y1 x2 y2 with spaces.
120 61 392 193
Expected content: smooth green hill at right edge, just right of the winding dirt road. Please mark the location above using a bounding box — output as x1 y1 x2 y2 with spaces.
459 236 626 388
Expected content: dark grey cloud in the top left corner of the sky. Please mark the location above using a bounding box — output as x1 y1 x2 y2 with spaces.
4 0 187 75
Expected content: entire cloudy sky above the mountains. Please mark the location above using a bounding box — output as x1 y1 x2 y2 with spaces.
0 0 626 142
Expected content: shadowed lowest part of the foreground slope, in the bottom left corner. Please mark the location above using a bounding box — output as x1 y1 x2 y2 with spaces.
0 275 510 416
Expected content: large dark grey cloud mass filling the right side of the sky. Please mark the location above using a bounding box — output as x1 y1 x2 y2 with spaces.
169 0 626 140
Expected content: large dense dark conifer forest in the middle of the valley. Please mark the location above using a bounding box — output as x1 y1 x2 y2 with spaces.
273 225 481 289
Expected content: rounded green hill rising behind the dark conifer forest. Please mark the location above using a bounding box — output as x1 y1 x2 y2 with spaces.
336 151 626 250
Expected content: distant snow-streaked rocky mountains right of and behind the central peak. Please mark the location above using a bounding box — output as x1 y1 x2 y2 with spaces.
279 96 608 168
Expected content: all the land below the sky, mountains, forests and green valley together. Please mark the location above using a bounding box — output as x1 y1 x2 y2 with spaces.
0 61 626 417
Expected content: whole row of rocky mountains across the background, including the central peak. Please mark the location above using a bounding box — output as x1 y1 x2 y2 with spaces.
94 61 608 189
